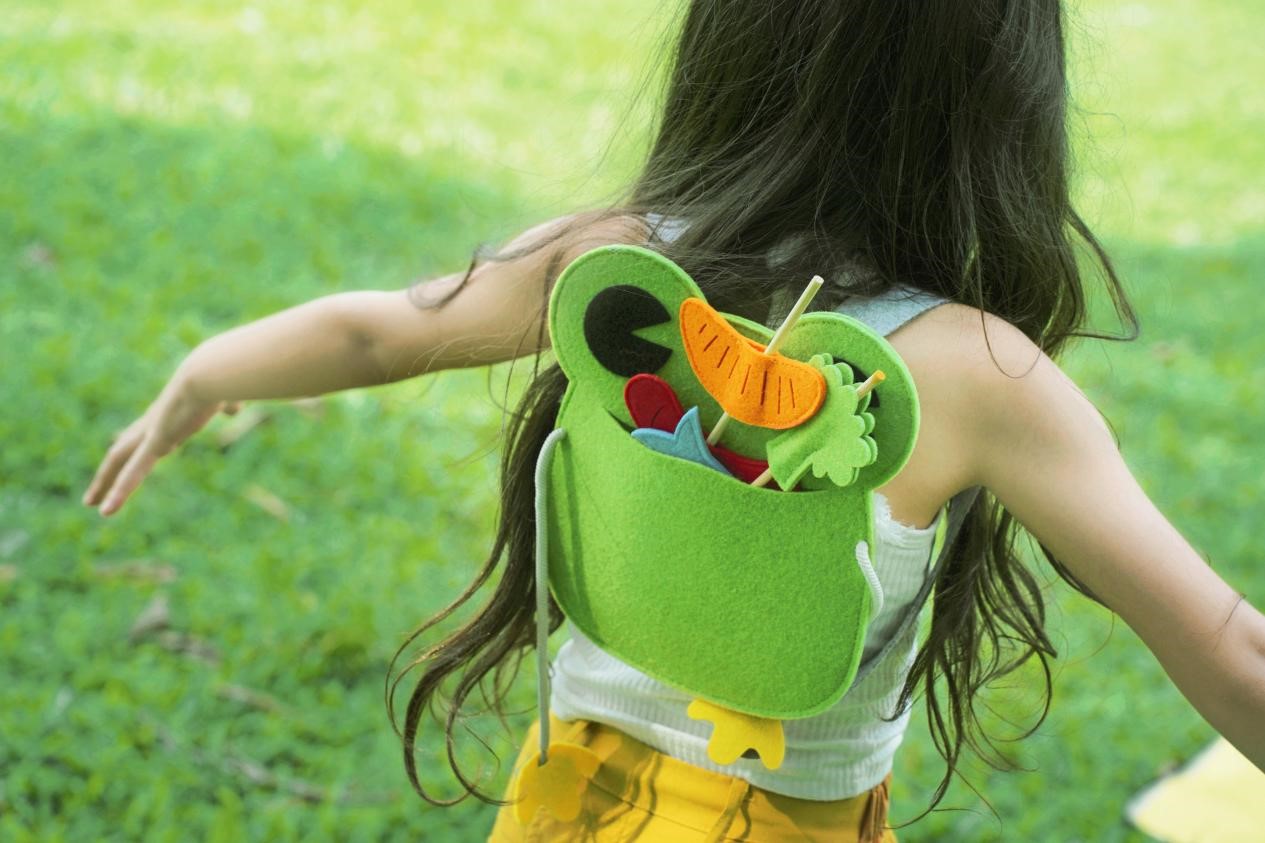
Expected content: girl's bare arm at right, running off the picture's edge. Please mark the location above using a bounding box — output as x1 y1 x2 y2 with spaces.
954 303 1265 770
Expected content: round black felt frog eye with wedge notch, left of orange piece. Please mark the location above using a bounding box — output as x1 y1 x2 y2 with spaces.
584 284 672 377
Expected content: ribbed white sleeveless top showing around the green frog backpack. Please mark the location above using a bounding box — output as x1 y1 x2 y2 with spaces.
550 492 945 800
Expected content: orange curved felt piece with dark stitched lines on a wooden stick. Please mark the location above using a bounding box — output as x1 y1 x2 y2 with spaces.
679 297 826 430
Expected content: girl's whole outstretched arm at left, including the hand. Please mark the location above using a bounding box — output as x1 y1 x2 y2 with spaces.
83 211 645 515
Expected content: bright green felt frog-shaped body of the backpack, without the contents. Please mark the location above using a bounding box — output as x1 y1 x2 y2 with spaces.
548 247 917 719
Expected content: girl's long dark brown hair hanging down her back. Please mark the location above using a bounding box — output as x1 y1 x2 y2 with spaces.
388 0 1137 810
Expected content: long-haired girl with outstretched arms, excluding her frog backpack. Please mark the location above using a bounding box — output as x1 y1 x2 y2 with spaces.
85 0 1265 840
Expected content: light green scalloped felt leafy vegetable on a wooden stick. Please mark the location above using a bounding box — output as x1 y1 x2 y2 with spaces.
767 354 878 489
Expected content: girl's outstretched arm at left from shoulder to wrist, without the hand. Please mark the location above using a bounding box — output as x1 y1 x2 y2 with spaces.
173 210 632 403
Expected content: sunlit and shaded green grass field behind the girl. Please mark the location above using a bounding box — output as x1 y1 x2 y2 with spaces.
0 0 1265 842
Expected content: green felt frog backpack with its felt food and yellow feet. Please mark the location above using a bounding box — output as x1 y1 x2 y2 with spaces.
514 246 961 821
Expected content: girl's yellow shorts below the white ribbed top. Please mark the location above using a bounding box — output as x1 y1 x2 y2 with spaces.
488 719 896 843
